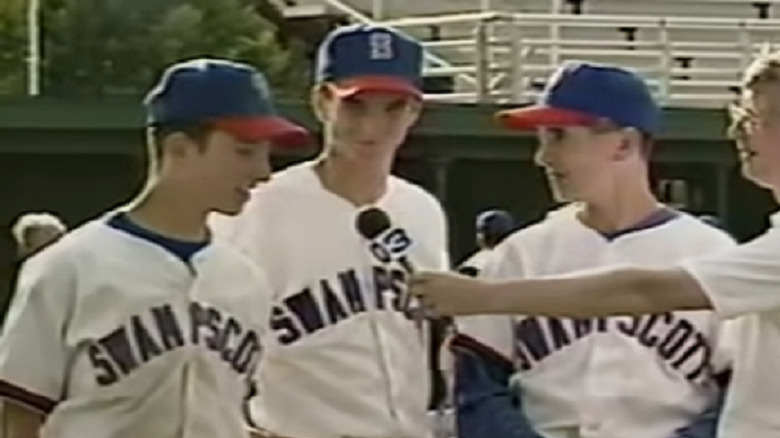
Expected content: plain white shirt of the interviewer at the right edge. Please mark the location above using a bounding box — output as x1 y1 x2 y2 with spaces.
683 213 780 438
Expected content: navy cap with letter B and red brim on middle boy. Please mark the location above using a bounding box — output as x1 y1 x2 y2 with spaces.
316 24 423 97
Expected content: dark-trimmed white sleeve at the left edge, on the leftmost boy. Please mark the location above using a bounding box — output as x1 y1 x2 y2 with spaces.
0 247 75 414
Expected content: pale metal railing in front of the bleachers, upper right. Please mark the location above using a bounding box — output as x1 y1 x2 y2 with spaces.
310 0 780 107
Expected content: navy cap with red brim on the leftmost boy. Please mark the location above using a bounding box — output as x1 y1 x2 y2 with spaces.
144 59 308 146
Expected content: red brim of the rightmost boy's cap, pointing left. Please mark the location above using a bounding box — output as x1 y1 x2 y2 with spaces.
496 105 598 131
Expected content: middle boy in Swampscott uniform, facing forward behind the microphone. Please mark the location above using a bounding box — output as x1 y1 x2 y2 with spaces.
210 25 447 438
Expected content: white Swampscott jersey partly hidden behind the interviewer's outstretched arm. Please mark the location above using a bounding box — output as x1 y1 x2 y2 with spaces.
458 205 734 438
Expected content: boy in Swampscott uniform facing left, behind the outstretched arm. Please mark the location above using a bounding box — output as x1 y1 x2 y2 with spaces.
432 62 734 438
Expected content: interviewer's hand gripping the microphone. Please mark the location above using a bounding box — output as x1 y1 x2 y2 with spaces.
409 272 500 316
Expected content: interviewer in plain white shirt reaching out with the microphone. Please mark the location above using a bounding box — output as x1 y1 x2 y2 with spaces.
413 53 780 438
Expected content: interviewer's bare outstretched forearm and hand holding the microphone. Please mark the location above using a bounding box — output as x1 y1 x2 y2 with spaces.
412 269 712 318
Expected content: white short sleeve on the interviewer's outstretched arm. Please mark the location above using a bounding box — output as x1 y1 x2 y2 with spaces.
682 228 780 319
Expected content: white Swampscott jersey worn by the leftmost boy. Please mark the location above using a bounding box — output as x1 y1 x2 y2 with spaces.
0 213 268 438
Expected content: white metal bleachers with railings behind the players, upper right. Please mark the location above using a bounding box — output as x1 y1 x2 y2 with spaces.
282 0 780 107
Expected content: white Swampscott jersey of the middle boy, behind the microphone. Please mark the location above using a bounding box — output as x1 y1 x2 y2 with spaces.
214 162 447 438
